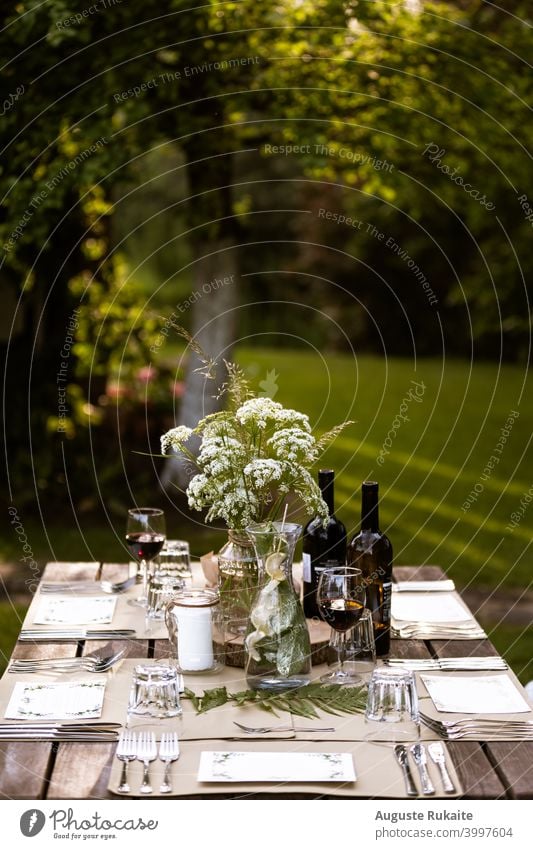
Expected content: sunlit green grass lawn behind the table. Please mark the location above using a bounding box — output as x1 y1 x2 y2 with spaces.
0 348 533 680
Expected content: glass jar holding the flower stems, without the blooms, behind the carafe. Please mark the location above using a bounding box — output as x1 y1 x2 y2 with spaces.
218 530 259 636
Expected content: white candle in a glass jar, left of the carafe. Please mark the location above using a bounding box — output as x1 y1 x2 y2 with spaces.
165 589 224 675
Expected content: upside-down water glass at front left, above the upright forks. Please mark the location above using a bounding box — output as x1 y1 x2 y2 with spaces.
128 663 181 719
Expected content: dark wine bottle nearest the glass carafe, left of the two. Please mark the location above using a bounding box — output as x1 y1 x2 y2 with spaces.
302 469 346 619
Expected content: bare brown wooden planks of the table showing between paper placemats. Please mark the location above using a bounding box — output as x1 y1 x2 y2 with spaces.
0 563 533 799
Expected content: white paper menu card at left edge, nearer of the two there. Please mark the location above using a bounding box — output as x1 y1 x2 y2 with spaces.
5 681 105 720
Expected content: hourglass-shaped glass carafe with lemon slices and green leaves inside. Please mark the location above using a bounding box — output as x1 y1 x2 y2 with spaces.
244 522 311 691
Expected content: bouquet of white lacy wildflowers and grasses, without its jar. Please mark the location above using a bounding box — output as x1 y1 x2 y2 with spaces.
161 364 354 530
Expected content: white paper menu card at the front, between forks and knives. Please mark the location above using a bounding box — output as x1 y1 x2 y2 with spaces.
198 752 356 782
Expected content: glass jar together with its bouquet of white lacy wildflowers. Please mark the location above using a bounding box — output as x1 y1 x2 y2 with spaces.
161 348 349 635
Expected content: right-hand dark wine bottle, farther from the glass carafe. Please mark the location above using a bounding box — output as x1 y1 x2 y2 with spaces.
346 481 392 657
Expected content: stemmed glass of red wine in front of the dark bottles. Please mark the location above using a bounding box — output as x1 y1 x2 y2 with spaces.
317 566 365 684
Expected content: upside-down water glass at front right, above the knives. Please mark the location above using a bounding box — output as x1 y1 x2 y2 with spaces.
365 667 420 742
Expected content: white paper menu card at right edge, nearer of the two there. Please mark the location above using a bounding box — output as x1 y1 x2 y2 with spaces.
420 674 531 714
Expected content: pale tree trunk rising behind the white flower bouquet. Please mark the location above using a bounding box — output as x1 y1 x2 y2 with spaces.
161 240 238 489
